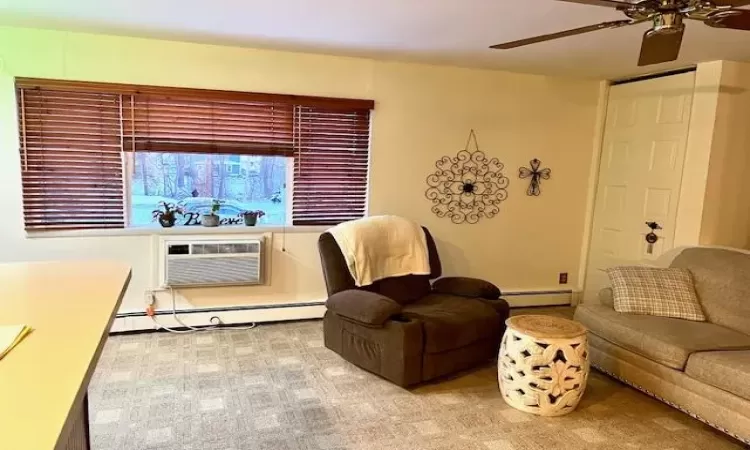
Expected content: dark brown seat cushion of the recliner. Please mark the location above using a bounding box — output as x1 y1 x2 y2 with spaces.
402 294 502 353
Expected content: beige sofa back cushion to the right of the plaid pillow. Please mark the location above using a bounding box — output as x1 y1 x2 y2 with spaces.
671 247 750 333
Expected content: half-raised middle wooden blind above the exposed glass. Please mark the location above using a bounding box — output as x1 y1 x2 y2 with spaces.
124 94 294 156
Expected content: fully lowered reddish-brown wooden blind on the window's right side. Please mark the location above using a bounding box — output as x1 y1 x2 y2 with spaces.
292 106 370 225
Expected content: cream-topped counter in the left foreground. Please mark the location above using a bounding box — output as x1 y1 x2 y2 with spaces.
0 261 130 450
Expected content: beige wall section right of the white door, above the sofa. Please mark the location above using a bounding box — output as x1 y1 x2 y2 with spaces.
675 61 750 248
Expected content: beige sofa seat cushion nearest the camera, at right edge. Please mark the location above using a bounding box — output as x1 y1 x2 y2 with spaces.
685 351 750 400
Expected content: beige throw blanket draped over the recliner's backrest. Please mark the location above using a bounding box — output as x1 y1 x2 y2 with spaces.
328 216 430 286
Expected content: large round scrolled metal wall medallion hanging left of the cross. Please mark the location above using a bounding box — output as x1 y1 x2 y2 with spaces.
425 130 510 223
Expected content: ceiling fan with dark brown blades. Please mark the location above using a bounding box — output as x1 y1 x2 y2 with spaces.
490 0 750 66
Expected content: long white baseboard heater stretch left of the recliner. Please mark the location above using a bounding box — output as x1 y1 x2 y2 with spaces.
109 303 326 333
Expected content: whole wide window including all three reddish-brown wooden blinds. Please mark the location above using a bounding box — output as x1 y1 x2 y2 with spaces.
16 79 373 230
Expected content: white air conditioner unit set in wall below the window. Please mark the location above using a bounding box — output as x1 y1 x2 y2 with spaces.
159 239 263 288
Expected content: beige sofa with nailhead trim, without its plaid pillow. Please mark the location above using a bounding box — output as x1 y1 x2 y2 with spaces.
575 247 750 444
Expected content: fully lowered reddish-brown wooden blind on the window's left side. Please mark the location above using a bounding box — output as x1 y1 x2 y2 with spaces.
17 88 125 230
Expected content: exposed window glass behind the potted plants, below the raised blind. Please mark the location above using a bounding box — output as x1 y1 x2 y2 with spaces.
128 152 291 226
